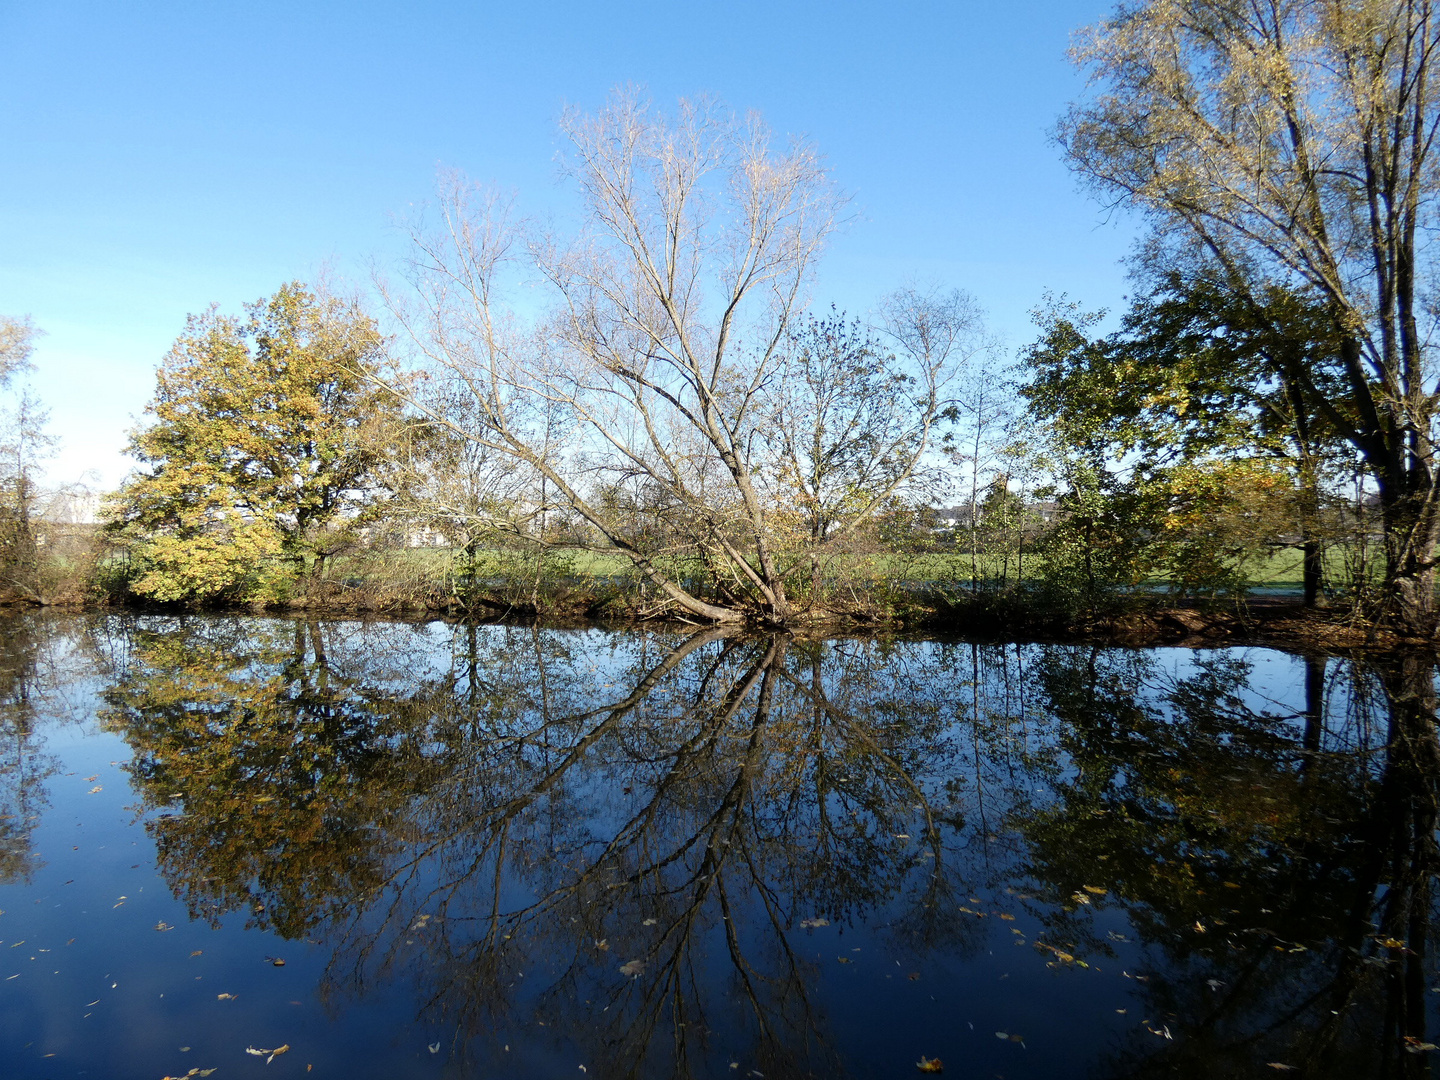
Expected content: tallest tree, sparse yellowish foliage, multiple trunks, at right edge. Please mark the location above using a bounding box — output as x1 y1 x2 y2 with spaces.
1058 0 1440 632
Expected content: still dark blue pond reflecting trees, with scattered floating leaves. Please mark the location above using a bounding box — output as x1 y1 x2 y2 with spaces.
0 613 1440 1080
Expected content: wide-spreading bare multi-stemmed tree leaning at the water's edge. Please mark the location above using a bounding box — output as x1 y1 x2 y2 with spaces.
389 96 963 622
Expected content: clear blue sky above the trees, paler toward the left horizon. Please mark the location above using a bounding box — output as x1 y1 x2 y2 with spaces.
0 0 1132 485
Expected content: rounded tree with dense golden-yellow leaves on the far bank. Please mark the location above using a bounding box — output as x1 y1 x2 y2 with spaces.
109 282 400 600
